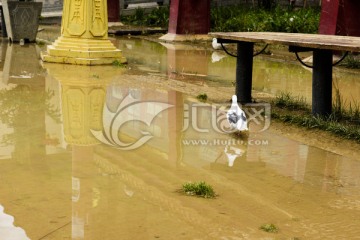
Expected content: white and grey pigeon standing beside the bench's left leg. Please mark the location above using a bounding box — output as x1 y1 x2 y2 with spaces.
226 95 248 132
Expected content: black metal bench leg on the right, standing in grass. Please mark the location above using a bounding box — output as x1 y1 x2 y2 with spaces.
312 49 333 116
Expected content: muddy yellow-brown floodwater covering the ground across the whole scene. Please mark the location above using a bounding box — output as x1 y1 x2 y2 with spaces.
0 31 360 240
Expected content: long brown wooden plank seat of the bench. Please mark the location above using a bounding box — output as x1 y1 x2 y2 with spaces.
209 32 360 52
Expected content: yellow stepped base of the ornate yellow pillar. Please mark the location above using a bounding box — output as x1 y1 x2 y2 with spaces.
41 36 126 65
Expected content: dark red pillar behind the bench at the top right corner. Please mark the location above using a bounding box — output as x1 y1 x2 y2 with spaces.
319 0 360 36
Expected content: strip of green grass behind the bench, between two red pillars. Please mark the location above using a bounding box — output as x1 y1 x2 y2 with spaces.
211 6 320 33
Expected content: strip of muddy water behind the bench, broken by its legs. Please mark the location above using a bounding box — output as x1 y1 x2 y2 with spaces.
112 38 360 104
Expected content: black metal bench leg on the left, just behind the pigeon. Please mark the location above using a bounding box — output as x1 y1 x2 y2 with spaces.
235 42 254 103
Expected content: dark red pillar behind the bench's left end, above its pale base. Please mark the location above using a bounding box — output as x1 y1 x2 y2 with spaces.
169 0 210 34
